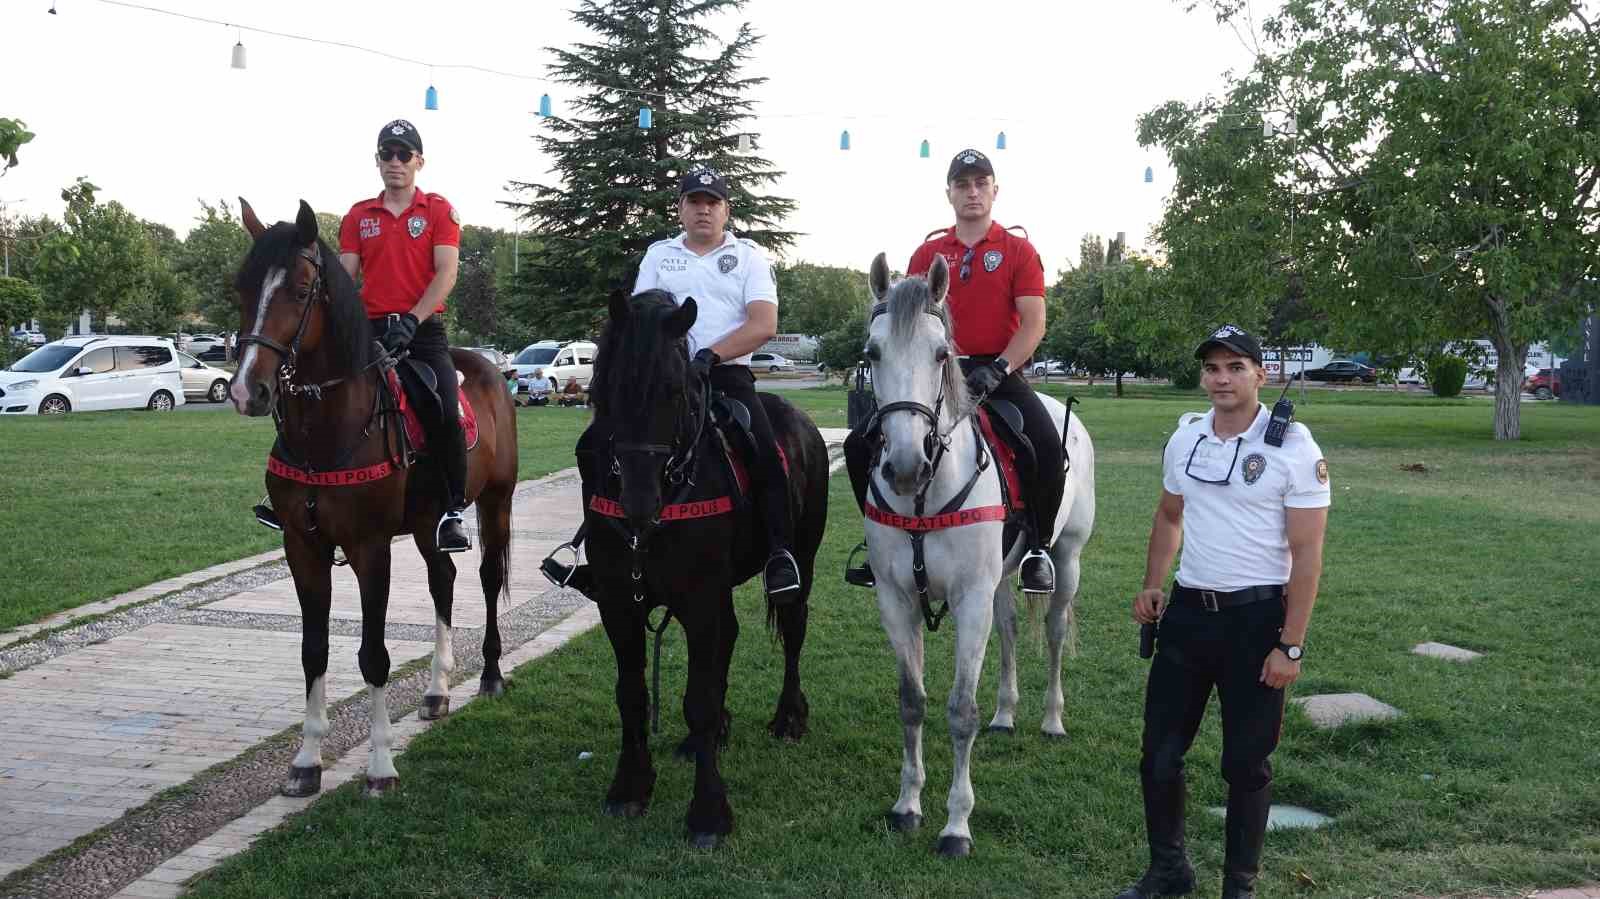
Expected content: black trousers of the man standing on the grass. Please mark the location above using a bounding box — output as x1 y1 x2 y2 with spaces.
1139 597 1283 793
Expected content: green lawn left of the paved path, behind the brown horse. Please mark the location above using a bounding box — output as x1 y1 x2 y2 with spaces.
0 408 587 630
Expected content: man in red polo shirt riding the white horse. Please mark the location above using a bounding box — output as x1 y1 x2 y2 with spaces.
845 150 1066 593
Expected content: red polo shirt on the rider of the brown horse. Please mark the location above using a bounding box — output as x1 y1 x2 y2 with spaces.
339 190 461 318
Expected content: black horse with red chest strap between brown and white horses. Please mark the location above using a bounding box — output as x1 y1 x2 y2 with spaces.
581 291 827 848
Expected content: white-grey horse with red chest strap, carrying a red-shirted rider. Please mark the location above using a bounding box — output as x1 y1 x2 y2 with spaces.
866 254 1094 856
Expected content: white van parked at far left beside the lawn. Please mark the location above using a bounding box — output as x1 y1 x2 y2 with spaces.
0 334 184 416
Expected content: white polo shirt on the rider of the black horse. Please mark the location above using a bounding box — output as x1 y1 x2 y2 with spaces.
634 230 778 365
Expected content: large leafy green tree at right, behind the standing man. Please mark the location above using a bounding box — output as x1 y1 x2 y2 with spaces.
1139 0 1600 440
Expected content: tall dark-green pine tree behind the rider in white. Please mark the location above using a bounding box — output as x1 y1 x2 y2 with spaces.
507 0 795 338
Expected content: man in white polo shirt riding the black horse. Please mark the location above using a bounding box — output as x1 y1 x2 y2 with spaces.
546 166 800 605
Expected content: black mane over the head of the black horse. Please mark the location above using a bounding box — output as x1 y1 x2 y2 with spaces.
589 290 688 418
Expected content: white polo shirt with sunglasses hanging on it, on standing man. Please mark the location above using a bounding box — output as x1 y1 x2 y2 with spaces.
1162 406 1333 590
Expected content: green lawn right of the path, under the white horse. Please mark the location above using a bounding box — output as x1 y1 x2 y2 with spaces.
172 389 1600 897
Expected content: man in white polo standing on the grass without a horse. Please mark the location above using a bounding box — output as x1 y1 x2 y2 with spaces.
1117 325 1330 899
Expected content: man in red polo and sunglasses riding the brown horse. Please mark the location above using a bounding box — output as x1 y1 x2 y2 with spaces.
339 118 472 552
